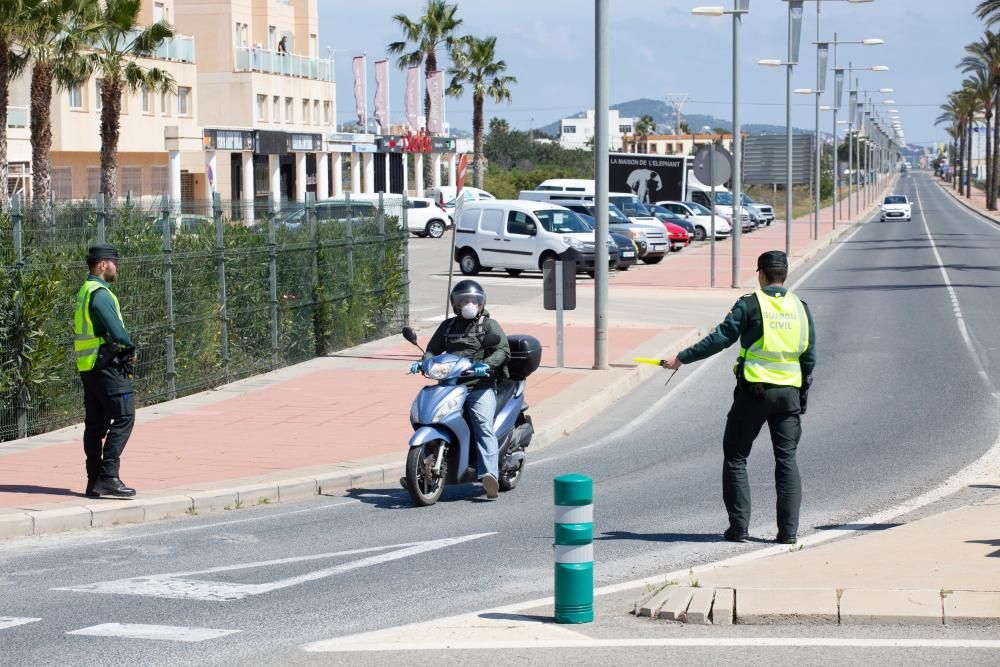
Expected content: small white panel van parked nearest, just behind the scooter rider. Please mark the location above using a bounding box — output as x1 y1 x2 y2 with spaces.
455 199 618 276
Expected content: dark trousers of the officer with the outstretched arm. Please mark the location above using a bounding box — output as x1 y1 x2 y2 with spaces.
722 386 802 535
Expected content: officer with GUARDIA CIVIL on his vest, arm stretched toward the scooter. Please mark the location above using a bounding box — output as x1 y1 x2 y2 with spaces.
662 250 816 544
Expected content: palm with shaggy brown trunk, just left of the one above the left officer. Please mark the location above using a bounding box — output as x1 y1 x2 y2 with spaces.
18 0 92 219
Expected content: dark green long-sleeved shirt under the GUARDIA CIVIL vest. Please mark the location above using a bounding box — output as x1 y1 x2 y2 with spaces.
677 285 816 380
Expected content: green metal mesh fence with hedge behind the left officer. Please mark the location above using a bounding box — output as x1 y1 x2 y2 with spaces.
0 197 409 441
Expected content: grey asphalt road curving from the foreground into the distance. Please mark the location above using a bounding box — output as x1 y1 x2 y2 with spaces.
0 175 1000 665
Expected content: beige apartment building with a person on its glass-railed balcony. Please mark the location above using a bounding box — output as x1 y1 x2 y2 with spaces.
173 0 341 209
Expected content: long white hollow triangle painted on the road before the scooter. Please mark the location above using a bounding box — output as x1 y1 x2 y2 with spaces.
52 532 496 602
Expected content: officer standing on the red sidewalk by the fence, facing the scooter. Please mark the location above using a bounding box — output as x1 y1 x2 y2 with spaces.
73 243 136 498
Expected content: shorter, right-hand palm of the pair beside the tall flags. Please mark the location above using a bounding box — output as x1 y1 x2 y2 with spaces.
448 37 517 188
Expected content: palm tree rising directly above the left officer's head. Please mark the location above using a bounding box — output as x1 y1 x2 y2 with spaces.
83 0 174 201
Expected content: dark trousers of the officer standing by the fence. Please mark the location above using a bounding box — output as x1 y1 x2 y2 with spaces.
80 368 135 480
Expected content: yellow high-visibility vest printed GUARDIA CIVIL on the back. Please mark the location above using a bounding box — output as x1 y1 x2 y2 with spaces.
740 290 809 387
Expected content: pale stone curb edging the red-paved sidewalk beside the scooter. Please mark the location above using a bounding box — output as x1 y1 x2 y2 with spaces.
0 194 892 540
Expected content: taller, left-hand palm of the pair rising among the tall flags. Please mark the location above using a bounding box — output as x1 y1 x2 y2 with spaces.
388 0 462 189
